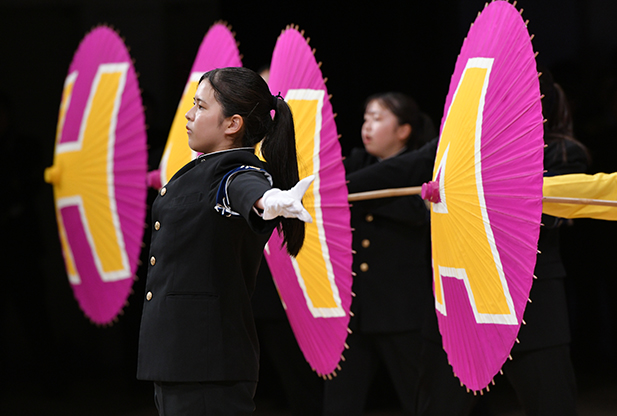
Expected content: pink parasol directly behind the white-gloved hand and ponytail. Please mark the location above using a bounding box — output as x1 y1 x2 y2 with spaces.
265 27 352 376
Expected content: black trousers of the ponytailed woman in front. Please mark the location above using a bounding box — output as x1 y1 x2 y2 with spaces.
154 381 257 416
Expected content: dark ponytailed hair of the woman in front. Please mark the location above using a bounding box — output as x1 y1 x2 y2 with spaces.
199 67 305 256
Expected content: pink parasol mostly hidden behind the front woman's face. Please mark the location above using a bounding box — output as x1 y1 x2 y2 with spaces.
148 22 242 188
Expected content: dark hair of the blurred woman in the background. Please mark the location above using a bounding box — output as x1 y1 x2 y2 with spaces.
364 92 437 150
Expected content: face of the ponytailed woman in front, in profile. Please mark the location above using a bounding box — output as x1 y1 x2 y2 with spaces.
185 79 230 153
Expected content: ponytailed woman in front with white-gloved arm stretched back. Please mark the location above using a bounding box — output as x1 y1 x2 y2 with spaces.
137 68 312 416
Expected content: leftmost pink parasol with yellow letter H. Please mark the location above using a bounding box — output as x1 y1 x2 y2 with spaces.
45 26 147 325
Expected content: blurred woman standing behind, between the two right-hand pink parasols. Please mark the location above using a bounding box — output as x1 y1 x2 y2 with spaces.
324 92 436 415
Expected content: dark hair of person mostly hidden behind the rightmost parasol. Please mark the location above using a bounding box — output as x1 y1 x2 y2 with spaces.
540 68 591 162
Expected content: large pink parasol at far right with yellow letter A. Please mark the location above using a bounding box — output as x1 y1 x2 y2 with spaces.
431 1 544 391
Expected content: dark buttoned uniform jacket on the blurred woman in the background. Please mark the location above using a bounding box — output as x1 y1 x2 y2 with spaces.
345 145 431 333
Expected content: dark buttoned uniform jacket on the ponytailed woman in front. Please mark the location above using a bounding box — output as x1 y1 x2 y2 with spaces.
137 148 278 382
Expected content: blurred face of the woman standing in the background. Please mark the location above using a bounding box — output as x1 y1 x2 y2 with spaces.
362 100 411 159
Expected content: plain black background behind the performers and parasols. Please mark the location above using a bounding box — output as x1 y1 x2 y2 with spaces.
0 0 617 415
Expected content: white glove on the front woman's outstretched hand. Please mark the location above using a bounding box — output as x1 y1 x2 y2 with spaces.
262 175 315 222
